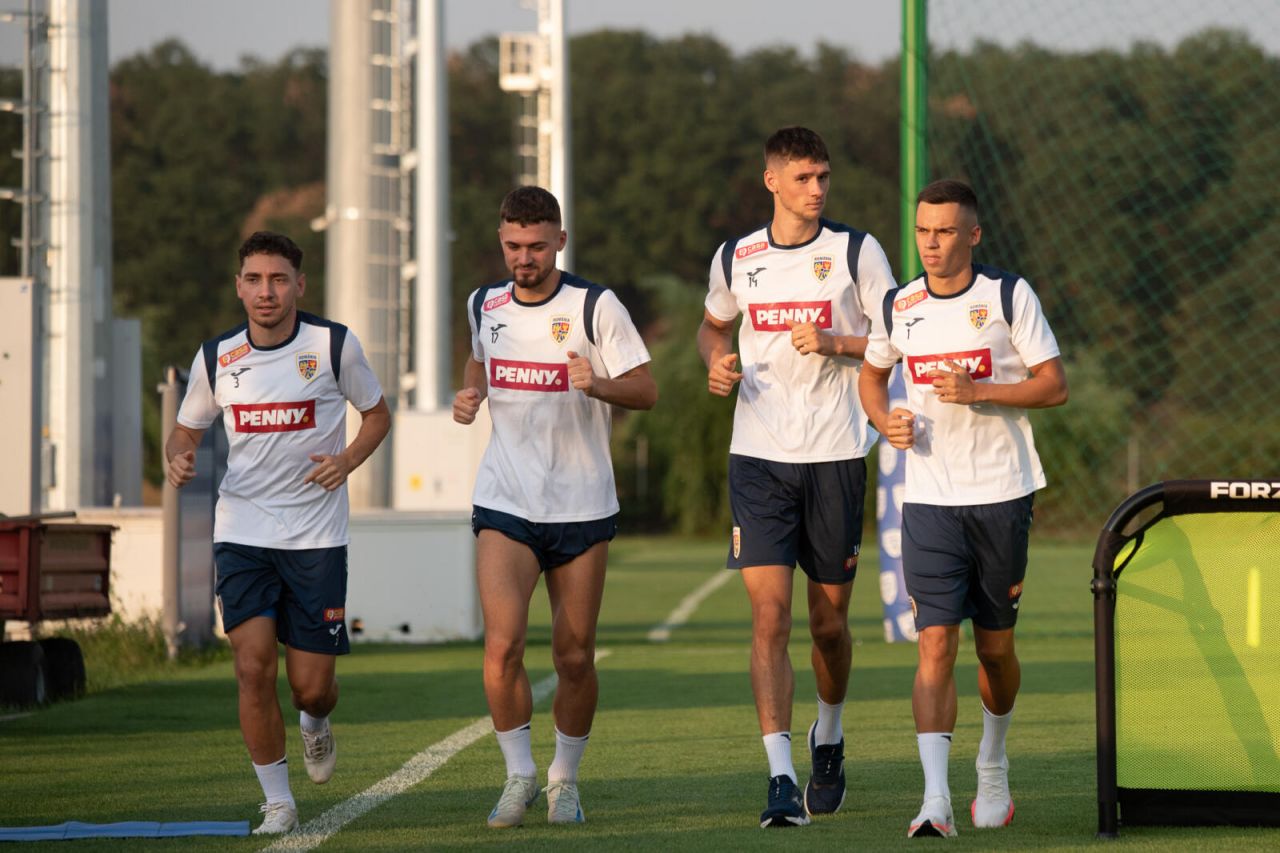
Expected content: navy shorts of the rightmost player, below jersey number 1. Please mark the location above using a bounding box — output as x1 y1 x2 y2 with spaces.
902 493 1036 630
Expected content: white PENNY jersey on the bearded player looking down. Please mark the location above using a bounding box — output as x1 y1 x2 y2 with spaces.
467 272 649 523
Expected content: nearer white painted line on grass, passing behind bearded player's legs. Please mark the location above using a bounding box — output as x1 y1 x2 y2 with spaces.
262 649 609 853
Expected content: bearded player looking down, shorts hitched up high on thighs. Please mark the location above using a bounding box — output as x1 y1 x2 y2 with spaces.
453 187 658 827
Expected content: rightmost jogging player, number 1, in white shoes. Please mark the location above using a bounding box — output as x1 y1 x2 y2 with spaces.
859 181 1068 836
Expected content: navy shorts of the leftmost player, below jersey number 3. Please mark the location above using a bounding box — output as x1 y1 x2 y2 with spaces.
214 542 351 654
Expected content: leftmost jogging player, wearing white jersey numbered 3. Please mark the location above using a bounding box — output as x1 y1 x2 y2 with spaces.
165 232 390 834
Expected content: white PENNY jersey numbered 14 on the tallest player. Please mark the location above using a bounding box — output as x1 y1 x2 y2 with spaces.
707 219 896 462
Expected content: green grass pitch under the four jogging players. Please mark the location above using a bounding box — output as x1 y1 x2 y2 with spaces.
0 538 1280 852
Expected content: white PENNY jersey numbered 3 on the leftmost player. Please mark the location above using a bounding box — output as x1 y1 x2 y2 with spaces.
178 311 383 549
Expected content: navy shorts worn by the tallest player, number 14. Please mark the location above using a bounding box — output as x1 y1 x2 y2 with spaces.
726 453 867 584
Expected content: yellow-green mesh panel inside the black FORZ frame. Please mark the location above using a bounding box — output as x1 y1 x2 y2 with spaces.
1115 512 1280 793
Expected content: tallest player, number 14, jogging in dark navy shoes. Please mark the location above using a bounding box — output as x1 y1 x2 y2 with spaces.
698 127 893 827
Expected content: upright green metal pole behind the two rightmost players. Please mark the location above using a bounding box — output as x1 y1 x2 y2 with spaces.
899 0 929 282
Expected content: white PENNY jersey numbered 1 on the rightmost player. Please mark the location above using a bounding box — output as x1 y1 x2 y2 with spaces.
867 264 1059 506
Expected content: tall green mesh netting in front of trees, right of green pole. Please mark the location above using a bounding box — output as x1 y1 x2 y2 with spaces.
928 0 1280 533
